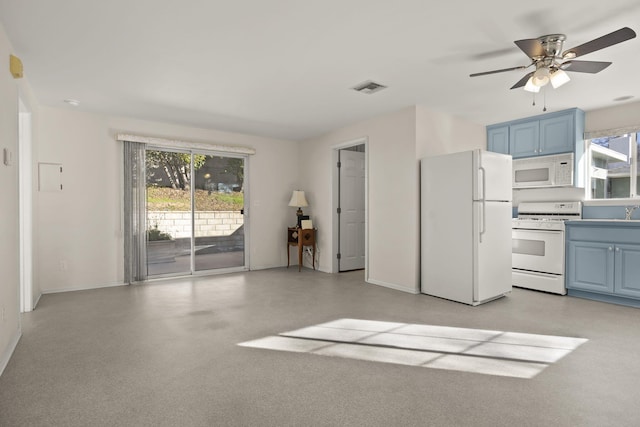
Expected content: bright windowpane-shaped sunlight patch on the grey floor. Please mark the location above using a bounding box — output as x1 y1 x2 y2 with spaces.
238 319 588 378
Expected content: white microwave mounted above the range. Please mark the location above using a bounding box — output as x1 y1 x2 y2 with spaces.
512 153 573 188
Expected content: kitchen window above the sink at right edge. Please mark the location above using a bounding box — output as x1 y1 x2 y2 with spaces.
586 131 640 199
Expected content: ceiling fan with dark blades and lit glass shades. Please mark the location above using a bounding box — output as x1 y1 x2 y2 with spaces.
470 27 636 92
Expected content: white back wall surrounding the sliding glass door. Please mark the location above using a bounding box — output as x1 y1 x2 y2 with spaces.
37 107 298 292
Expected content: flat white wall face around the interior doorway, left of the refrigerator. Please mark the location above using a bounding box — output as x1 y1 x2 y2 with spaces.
300 107 418 292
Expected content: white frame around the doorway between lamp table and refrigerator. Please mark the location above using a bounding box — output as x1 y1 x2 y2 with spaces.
331 136 369 276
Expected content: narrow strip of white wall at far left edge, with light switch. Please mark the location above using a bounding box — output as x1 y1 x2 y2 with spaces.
0 25 20 374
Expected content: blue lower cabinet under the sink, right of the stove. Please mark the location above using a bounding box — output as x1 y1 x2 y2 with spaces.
566 221 640 307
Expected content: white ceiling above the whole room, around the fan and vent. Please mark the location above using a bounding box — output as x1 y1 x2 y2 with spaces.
0 0 640 140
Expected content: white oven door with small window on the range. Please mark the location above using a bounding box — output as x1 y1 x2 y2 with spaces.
511 228 564 274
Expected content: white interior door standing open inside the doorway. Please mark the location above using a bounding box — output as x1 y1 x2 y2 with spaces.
340 150 365 271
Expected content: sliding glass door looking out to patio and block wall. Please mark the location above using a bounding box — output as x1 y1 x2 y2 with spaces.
145 147 245 278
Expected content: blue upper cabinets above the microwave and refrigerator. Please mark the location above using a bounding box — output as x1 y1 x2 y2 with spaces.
487 108 584 159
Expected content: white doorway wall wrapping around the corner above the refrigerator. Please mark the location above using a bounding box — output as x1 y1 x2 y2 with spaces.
300 106 486 292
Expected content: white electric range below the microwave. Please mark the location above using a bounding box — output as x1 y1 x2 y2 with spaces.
512 202 582 295
